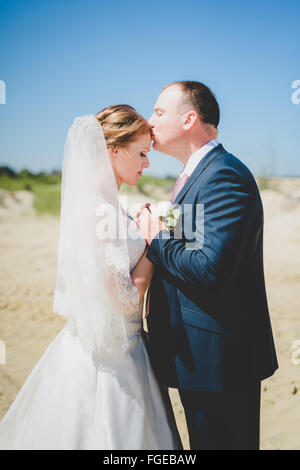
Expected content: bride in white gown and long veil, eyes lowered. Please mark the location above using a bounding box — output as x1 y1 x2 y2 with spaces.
0 105 182 450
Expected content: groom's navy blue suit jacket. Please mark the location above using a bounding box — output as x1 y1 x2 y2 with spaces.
147 145 278 391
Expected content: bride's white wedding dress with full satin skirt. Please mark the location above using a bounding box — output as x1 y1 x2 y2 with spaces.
0 217 182 450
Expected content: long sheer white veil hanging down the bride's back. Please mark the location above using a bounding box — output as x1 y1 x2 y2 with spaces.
53 115 144 404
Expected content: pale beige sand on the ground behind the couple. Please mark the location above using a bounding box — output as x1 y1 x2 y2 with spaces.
0 186 300 449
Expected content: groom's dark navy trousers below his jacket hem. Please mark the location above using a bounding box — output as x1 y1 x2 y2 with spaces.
179 381 261 450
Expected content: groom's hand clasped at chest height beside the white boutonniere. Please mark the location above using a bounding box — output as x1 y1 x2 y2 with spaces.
137 203 167 245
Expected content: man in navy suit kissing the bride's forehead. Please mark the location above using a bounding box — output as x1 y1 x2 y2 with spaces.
138 81 278 450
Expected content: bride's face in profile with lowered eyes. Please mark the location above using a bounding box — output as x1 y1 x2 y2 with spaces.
110 133 151 189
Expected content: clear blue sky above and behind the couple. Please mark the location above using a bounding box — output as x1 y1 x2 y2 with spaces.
0 0 300 176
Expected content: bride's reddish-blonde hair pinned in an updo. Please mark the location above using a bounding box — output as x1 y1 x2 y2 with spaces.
96 104 151 148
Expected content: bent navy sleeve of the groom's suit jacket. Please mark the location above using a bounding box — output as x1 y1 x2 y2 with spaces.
147 168 252 288
